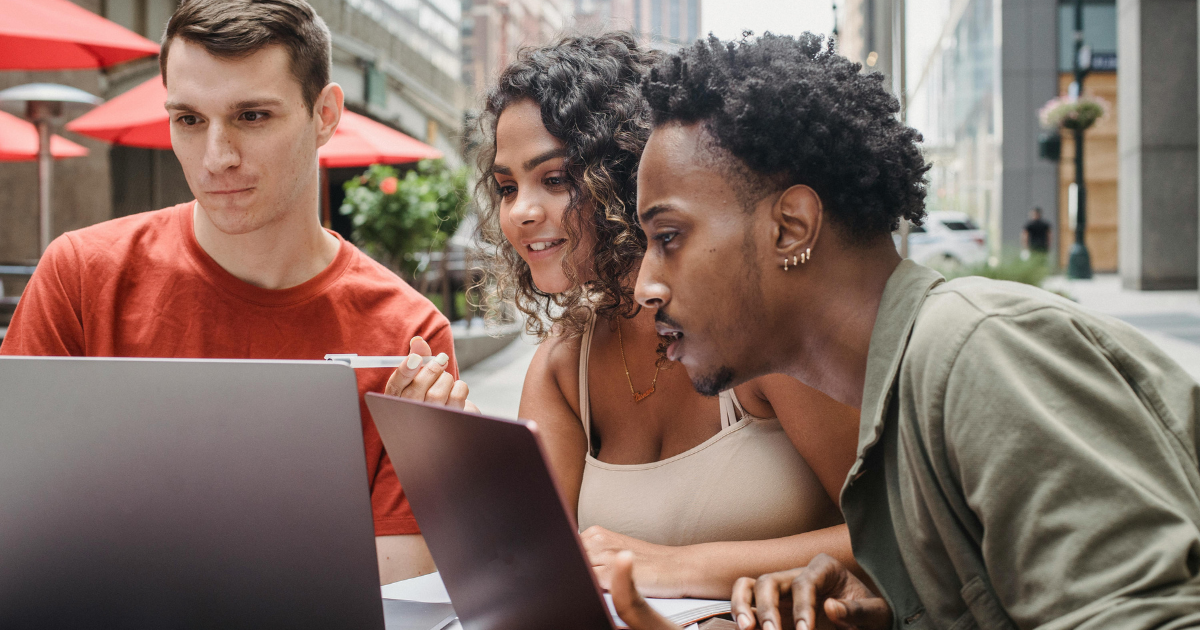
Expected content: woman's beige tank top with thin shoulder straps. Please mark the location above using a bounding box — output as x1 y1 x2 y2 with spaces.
578 316 842 545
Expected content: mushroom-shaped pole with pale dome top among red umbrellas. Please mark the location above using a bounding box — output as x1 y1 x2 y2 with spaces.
0 83 103 256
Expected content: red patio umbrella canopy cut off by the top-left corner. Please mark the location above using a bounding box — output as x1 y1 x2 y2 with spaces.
0 0 158 70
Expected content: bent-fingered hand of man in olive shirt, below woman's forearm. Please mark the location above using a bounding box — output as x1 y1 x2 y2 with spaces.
731 553 892 630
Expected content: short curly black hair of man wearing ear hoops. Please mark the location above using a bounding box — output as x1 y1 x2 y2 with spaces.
642 32 929 244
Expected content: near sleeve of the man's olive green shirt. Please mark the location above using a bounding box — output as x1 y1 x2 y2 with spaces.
934 308 1200 629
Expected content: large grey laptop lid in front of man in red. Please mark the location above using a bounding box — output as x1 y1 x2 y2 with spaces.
0 358 384 630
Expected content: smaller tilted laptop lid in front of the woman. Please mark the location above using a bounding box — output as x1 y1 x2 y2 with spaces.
366 394 613 630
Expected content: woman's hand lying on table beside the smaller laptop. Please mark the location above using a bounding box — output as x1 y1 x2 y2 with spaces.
580 526 689 598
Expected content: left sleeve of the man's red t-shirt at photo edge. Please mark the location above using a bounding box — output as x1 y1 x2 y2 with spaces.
0 234 86 356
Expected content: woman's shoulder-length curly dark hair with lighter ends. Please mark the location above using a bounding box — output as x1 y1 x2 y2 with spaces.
475 32 659 337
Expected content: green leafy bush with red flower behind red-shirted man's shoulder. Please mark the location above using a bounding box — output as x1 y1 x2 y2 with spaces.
340 160 468 280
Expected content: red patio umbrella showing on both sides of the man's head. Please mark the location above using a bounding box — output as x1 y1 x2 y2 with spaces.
65 75 442 168
